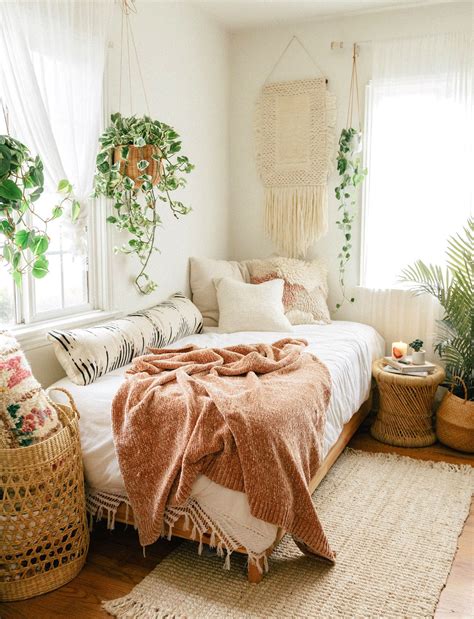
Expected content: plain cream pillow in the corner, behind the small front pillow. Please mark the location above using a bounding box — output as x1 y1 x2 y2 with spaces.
189 258 249 327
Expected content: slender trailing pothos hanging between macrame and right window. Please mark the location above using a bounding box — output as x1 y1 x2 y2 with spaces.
335 127 367 309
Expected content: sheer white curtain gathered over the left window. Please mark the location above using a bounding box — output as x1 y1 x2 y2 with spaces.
0 0 113 249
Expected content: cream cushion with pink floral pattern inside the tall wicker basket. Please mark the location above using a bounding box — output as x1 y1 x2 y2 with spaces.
0 331 62 448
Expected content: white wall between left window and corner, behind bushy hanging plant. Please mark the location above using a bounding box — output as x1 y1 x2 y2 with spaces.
26 0 229 385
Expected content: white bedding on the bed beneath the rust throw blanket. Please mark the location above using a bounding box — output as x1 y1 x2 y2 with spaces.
51 321 385 554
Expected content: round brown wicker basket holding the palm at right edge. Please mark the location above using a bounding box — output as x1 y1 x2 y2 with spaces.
436 377 474 453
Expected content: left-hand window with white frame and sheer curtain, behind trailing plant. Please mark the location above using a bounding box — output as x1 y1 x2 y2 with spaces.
0 2 110 339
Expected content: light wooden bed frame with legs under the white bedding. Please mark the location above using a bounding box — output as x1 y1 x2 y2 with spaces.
115 389 373 584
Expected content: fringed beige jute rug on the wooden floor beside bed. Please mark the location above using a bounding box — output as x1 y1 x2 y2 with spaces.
104 450 474 619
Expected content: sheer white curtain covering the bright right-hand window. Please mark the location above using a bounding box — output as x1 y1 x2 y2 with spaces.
354 33 473 356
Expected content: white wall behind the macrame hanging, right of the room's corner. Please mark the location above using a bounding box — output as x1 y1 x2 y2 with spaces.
230 2 472 318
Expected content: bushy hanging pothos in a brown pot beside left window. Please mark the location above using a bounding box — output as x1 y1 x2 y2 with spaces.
94 113 194 294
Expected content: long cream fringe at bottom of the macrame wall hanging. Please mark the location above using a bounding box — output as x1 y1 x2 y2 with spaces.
264 185 328 258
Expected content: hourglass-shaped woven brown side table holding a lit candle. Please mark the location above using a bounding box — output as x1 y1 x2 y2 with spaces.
370 359 445 447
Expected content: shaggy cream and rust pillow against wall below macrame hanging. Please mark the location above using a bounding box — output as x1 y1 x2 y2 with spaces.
247 256 331 325
